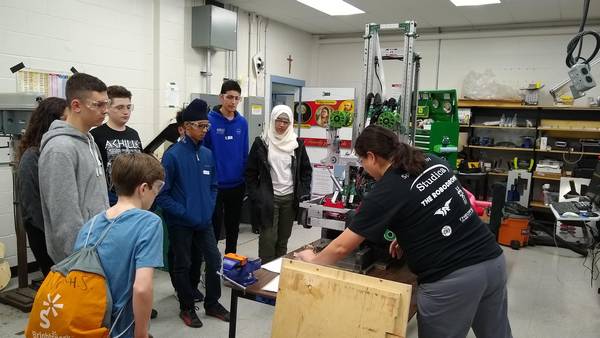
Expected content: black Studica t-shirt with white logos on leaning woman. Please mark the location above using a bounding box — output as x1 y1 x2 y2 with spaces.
349 155 502 283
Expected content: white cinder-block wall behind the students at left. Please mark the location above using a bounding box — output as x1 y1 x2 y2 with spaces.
0 0 313 265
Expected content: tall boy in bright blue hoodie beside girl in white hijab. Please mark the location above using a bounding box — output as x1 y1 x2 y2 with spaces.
205 80 248 253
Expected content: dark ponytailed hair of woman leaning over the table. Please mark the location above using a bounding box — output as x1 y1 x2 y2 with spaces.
354 126 425 175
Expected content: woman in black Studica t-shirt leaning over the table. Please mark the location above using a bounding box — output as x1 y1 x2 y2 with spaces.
296 126 512 338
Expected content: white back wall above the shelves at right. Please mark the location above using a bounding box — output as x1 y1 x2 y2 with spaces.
314 27 600 104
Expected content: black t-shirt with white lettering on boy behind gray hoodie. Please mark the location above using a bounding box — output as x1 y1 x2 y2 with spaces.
90 123 142 191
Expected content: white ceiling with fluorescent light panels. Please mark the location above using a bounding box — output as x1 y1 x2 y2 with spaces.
221 0 600 34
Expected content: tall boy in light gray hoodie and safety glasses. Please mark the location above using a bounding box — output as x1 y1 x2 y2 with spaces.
39 73 110 262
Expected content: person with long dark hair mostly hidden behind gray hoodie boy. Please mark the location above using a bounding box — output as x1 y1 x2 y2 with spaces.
17 97 67 276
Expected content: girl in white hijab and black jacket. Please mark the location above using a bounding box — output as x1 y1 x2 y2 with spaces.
246 105 312 263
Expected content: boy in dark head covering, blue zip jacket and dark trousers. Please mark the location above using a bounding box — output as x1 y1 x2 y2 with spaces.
156 99 229 327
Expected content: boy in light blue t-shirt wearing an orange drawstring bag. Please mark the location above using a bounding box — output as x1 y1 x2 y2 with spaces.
74 153 164 337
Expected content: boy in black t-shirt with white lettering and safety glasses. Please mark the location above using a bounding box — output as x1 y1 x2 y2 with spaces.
90 86 142 205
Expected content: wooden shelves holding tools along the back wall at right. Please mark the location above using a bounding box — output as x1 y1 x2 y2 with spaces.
459 100 600 212
